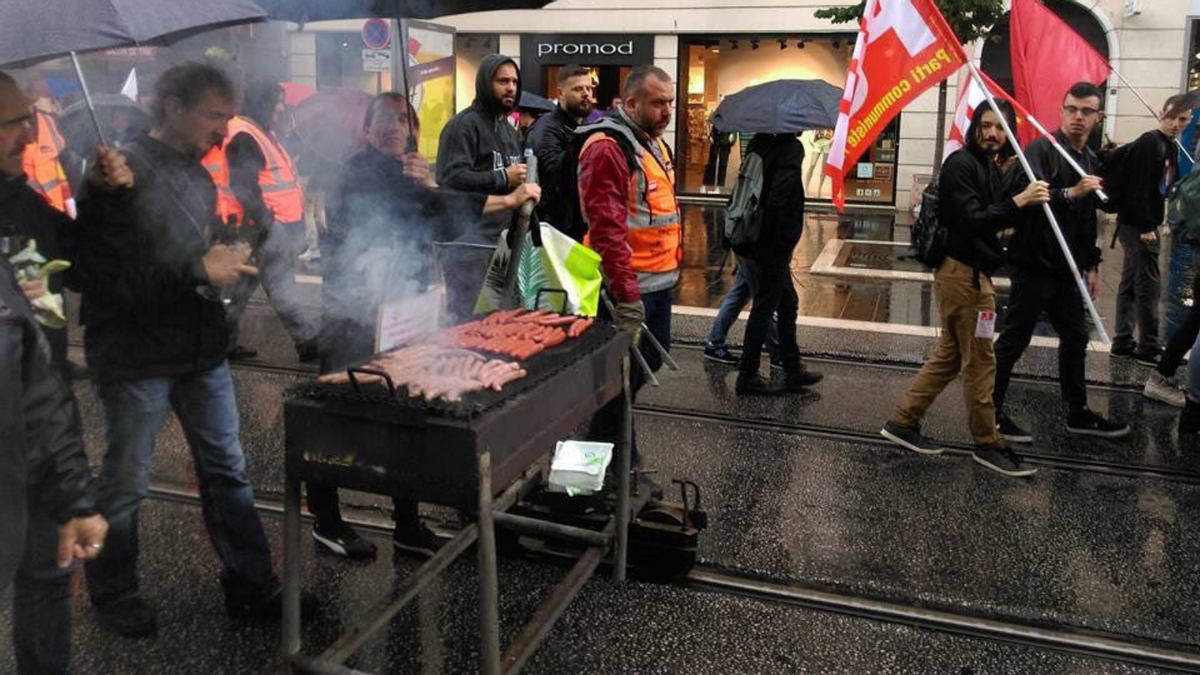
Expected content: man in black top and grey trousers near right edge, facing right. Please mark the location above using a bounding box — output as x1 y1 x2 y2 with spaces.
1105 96 1192 366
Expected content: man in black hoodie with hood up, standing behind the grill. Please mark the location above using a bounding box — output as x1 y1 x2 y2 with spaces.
437 54 527 319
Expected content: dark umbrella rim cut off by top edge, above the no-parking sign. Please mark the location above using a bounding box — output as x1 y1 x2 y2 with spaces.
258 0 551 23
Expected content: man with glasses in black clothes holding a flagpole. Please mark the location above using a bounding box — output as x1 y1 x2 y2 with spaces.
992 82 1129 443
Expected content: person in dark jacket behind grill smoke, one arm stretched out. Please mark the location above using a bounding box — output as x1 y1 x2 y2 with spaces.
319 92 541 560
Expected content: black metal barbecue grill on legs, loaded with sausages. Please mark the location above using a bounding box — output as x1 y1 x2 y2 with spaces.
283 323 631 675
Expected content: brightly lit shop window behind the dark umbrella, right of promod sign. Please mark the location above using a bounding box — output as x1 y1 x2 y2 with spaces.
677 35 899 204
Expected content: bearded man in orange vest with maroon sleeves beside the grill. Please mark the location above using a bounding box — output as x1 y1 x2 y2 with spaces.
576 66 683 461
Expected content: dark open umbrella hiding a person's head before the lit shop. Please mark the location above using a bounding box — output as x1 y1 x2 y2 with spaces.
710 79 841 133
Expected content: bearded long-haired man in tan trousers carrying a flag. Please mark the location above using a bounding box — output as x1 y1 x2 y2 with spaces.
880 101 1050 477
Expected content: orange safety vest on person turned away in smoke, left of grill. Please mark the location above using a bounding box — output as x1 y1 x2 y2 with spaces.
200 117 304 222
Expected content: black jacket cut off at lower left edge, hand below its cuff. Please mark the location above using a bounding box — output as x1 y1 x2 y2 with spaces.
0 256 96 587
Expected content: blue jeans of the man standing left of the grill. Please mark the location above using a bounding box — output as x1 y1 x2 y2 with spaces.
84 364 280 605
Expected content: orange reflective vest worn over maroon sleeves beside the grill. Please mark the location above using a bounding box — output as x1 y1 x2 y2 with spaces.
580 125 683 274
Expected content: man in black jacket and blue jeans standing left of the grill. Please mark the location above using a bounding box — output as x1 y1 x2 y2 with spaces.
77 62 312 637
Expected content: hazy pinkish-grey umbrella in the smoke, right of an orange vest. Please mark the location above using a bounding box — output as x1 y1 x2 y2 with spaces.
292 89 371 163
